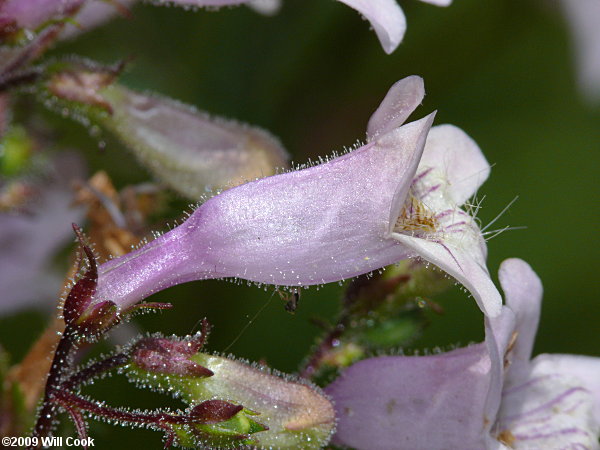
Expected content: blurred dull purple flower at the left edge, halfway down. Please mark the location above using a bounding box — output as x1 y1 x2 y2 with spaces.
0 153 85 314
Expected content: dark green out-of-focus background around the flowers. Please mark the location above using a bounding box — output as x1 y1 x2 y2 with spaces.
0 0 600 448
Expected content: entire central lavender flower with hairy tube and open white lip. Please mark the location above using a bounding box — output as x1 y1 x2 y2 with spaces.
90 76 501 315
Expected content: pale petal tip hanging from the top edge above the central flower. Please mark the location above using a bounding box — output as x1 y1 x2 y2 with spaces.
338 0 452 53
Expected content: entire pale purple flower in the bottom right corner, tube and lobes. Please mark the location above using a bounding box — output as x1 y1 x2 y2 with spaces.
326 259 600 450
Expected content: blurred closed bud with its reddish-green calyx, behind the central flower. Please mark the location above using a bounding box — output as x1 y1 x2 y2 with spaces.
45 61 288 200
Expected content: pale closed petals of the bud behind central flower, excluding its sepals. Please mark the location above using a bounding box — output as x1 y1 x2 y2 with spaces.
102 85 287 200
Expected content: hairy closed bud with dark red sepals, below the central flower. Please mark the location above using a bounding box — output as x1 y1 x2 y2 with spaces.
125 338 335 448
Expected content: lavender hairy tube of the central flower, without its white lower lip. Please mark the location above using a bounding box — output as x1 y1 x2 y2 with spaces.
97 77 433 305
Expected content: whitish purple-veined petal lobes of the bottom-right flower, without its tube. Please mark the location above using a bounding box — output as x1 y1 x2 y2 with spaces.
492 260 600 449
